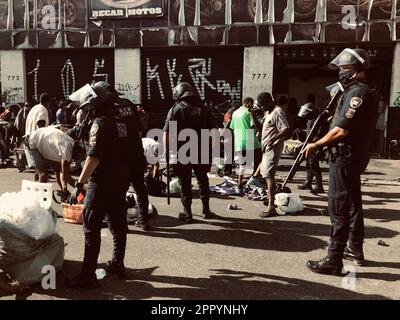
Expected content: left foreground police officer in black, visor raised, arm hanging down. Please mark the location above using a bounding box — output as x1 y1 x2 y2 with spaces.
66 83 130 288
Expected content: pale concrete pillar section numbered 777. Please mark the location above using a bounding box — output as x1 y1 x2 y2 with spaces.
242 47 274 100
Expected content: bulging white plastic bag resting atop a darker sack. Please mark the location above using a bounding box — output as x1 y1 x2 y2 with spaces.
0 192 56 240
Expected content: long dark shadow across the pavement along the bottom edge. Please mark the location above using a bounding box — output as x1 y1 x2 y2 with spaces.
5 261 388 300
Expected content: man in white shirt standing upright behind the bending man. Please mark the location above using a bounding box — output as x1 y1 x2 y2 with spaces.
24 93 50 168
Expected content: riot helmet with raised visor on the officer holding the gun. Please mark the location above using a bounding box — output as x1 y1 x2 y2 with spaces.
328 48 371 72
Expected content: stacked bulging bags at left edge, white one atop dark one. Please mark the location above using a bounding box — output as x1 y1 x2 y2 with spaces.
0 191 64 285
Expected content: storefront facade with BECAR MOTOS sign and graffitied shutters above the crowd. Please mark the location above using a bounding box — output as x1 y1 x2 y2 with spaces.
0 0 400 155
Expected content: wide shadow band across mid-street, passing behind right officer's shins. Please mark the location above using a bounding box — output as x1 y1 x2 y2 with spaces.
131 216 398 252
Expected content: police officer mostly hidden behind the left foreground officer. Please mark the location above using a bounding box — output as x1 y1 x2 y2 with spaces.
96 82 150 230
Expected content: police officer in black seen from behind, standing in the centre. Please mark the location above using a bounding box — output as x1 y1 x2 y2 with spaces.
164 82 215 223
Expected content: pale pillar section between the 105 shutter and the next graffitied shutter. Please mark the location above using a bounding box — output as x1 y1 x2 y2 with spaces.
114 49 142 104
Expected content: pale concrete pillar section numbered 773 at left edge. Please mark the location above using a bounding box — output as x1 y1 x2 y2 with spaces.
0 50 26 104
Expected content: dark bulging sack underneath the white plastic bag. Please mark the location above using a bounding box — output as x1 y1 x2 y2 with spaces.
0 218 64 285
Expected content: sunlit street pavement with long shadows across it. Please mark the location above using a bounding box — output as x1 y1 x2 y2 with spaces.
0 159 400 300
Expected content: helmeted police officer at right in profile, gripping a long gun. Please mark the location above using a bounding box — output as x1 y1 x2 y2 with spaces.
305 48 378 275
